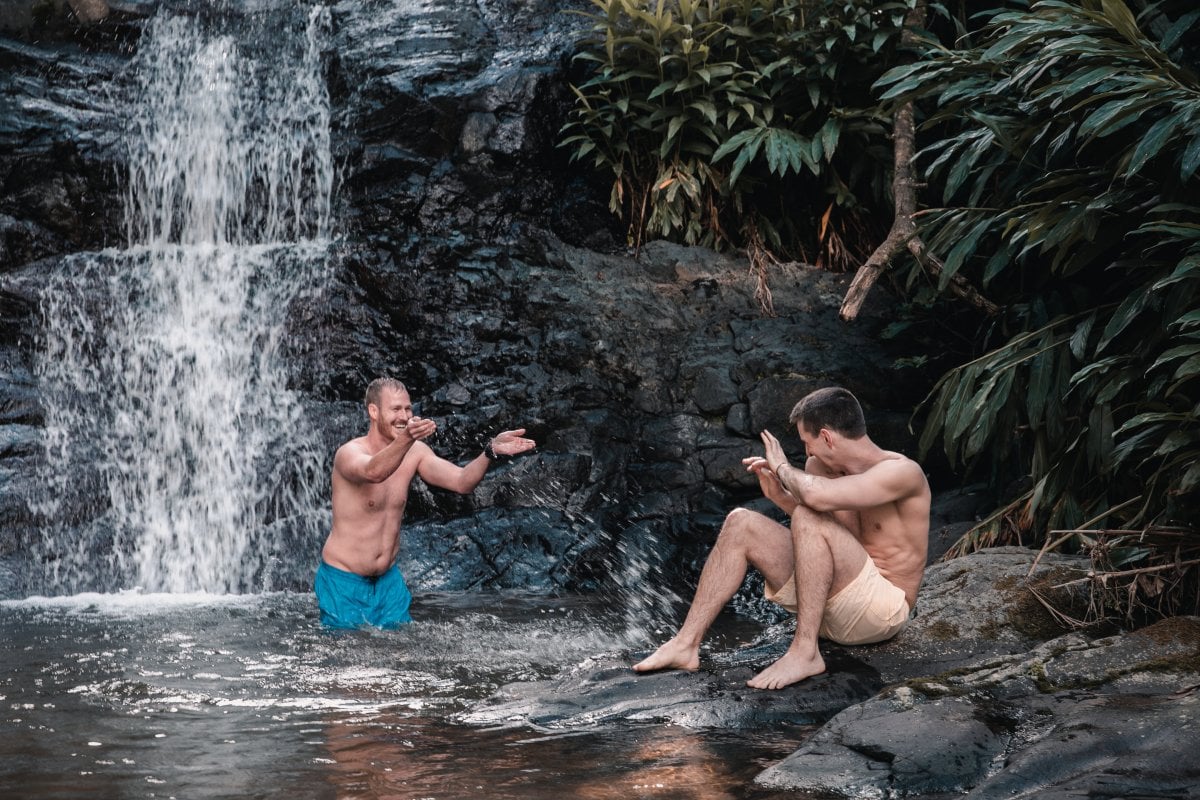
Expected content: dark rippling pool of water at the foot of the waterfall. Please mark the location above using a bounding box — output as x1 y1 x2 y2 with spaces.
0 593 808 800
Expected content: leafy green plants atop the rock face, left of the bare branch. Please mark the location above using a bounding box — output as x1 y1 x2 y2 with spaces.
563 0 907 266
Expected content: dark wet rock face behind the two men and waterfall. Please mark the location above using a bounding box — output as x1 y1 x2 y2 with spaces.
0 0 926 589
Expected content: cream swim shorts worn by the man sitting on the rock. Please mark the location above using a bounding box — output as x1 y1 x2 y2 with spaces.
763 559 910 644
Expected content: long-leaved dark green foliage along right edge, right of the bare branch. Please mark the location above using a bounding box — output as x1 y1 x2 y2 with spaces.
880 0 1200 623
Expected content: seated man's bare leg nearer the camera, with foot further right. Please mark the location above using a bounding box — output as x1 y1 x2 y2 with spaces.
746 506 869 688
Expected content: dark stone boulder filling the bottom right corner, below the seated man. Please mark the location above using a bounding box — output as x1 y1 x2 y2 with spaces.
756 618 1200 800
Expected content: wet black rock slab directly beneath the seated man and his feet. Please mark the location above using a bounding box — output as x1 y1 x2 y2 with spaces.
464 548 1099 728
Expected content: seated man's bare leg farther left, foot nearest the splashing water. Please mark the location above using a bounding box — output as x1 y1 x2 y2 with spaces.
634 509 792 672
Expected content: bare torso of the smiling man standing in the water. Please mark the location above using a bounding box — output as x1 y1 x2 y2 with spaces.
322 437 425 576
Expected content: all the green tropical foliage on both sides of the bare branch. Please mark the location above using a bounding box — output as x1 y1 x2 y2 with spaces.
564 0 1200 618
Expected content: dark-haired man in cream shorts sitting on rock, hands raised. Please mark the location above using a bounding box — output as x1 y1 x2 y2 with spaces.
634 387 930 688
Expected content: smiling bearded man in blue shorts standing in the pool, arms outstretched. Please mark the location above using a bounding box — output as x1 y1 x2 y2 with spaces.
313 378 534 627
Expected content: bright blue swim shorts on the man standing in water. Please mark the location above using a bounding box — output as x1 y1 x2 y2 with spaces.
312 561 413 627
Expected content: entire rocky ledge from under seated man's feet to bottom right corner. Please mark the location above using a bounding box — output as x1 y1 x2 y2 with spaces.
461 548 1200 799
